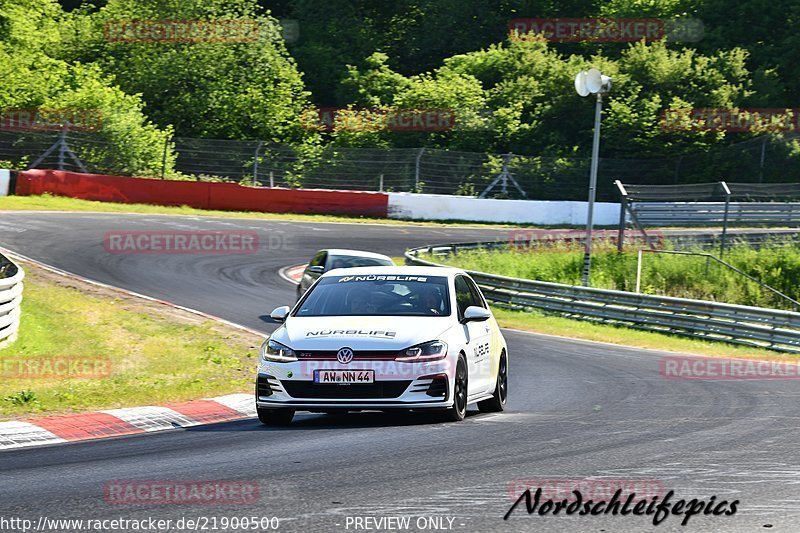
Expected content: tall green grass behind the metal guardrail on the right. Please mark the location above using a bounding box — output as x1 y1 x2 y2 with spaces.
436 243 800 310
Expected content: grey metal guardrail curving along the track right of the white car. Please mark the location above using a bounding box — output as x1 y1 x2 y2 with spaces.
405 243 800 353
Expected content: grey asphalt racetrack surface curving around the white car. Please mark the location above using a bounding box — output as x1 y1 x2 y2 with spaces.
0 213 800 532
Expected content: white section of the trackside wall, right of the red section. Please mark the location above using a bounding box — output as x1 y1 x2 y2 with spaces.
389 192 619 226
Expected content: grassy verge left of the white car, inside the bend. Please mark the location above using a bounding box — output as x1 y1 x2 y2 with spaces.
0 263 261 419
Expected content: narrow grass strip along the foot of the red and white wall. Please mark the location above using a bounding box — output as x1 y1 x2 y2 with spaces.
0 194 600 228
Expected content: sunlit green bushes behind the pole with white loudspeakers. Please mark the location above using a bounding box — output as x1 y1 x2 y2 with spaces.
334 36 750 157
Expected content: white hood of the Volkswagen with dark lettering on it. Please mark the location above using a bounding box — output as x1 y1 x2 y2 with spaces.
272 316 451 350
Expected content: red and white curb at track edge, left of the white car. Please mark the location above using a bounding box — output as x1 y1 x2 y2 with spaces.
0 394 256 450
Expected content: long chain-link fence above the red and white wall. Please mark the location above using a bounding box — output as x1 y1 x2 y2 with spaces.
0 131 800 201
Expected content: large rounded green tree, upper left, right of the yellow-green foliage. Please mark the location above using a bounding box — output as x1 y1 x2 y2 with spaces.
65 0 314 143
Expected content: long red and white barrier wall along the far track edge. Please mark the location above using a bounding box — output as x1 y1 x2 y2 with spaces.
16 170 620 222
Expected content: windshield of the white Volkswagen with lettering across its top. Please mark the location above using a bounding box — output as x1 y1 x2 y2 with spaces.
293 275 450 317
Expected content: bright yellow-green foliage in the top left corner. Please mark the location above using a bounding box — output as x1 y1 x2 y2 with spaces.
0 0 172 175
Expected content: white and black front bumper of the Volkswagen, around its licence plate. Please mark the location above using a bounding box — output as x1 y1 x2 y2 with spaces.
256 359 453 410
